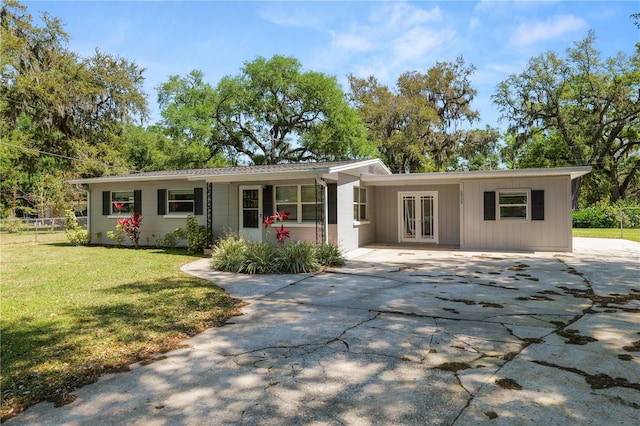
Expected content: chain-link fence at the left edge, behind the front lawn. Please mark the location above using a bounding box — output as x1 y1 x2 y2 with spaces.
0 216 87 244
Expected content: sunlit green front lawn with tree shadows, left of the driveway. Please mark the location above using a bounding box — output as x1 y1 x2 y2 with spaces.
0 241 235 419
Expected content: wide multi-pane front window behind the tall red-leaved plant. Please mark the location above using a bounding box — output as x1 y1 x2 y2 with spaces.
275 185 324 223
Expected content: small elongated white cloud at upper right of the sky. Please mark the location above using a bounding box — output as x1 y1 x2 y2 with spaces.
510 15 586 46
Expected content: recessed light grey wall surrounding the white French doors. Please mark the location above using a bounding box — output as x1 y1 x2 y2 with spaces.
373 184 460 245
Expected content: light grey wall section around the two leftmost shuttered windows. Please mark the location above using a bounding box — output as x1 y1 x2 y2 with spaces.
89 180 207 245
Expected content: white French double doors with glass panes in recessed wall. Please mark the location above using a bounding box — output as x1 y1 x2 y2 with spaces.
398 191 438 244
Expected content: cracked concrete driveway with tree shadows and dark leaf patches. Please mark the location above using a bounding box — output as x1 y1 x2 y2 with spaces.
7 239 640 425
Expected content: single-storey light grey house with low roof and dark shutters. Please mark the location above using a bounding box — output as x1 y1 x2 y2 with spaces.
72 159 590 251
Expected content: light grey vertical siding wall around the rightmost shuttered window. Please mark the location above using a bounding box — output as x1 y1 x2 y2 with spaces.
461 176 572 251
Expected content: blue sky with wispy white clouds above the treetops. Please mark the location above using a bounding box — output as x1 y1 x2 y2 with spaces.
23 0 640 127
